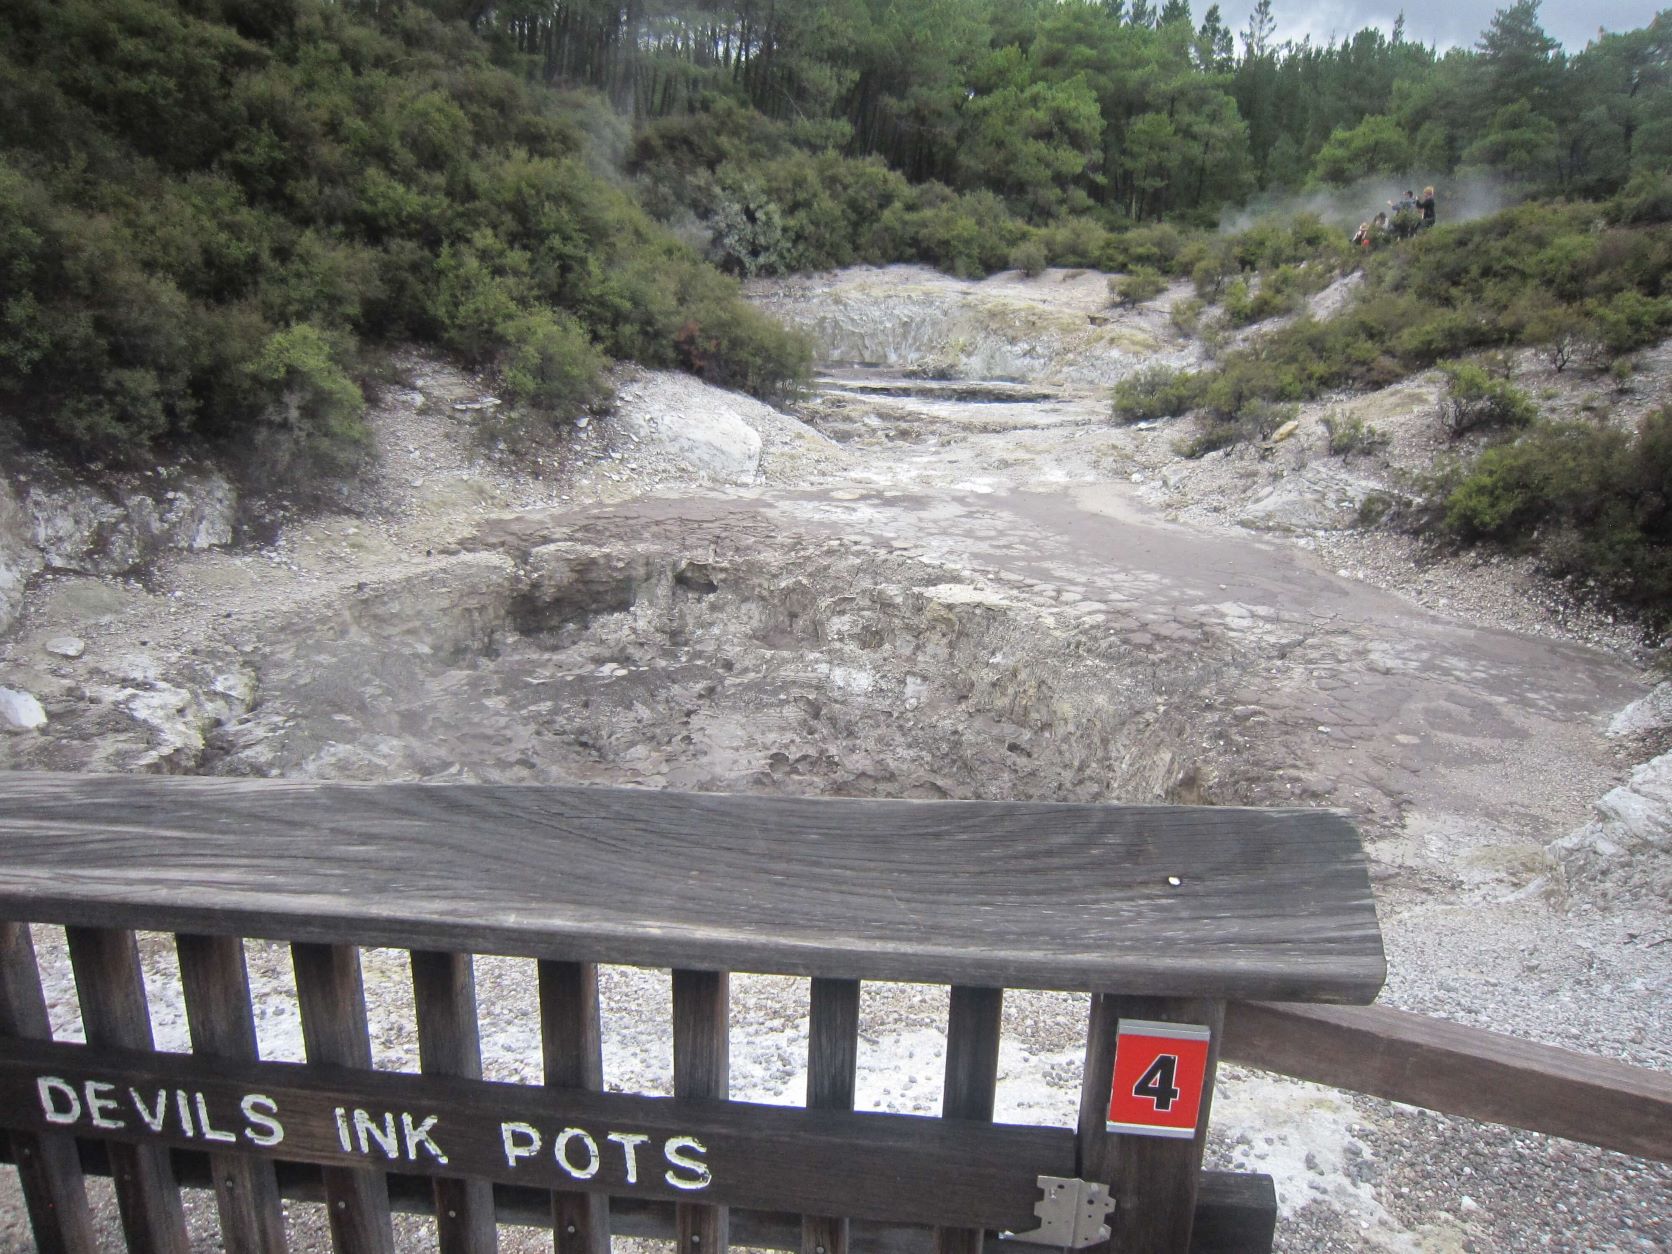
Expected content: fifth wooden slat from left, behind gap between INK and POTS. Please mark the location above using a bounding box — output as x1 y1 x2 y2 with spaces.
411 950 500 1254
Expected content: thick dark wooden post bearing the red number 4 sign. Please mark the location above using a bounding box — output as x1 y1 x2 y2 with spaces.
1080 995 1226 1254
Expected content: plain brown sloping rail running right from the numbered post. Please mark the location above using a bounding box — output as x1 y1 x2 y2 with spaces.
1224 1003 1672 1162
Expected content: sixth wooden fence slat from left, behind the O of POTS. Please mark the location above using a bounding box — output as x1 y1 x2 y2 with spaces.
538 961 610 1254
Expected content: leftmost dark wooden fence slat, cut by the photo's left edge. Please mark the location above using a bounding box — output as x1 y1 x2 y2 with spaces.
0 923 99 1254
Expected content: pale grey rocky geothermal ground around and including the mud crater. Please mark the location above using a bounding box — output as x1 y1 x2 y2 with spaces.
0 268 1672 1251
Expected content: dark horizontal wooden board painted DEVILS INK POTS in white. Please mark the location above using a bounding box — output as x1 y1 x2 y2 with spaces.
0 1042 1075 1229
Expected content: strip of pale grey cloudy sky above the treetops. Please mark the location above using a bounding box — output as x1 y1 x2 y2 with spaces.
1217 0 1667 52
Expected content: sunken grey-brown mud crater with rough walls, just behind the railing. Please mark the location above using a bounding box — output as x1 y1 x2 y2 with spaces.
202 525 1209 801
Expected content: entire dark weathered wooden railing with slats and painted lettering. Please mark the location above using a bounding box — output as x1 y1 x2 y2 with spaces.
0 774 1672 1254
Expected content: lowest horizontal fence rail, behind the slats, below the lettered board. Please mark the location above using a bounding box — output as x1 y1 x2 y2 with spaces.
0 1140 1277 1254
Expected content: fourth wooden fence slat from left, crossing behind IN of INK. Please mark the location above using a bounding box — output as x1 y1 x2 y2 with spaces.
291 941 395 1254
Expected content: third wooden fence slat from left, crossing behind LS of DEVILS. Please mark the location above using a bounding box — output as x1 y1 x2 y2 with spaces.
174 933 286 1254
